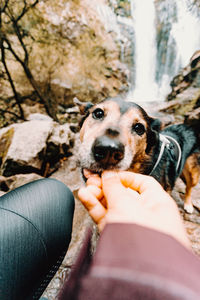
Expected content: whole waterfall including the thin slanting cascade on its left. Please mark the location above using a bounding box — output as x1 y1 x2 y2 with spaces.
95 0 200 101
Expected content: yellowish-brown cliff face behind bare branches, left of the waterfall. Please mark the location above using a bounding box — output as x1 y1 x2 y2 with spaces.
0 0 130 117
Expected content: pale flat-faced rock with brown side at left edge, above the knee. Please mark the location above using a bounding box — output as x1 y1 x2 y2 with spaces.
0 121 53 176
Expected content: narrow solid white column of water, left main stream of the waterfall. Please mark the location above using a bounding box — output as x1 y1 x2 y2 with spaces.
131 0 158 101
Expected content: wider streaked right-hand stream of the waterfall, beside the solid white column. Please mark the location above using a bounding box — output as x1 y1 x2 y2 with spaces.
156 0 200 100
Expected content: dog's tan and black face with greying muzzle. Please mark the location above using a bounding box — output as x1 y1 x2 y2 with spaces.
76 98 160 173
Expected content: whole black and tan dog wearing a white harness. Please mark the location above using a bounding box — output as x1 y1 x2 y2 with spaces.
74 97 200 213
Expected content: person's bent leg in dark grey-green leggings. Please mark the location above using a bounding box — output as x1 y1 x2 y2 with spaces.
0 179 74 300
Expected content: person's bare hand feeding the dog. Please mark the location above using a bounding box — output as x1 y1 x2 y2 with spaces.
78 171 189 246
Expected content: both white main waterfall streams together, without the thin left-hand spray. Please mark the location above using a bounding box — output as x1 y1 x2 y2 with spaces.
131 0 200 101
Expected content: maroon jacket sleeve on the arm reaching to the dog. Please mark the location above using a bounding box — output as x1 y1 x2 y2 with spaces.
59 224 200 300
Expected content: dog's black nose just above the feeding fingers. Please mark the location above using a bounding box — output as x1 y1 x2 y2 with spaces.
92 136 124 167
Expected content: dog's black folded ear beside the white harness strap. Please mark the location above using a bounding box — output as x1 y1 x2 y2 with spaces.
146 118 162 154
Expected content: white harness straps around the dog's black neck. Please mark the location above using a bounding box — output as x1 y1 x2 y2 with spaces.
149 133 182 175
